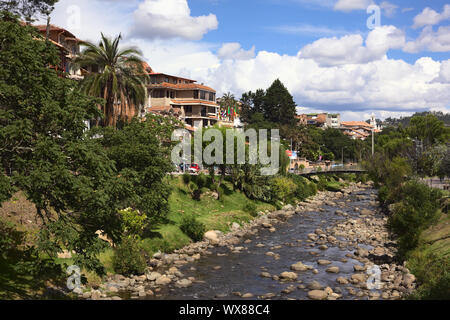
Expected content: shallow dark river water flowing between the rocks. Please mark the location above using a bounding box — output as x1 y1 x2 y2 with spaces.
146 189 376 300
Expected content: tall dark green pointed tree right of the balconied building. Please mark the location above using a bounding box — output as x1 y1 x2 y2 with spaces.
264 79 296 124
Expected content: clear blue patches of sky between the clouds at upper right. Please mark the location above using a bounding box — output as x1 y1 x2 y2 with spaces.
190 0 450 62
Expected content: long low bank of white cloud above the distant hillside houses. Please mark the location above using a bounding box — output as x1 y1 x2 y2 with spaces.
202 51 450 112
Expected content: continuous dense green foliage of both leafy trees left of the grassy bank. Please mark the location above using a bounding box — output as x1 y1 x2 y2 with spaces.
0 14 171 273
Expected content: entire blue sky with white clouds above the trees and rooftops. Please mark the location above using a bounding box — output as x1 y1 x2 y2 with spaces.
48 0 450 120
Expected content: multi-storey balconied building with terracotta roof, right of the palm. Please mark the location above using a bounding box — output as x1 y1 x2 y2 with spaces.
146 71 219 131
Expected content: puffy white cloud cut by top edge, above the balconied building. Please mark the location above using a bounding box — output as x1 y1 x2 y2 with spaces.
132 0 218 40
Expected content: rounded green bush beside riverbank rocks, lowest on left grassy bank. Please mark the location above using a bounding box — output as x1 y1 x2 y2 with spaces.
112 237 147 276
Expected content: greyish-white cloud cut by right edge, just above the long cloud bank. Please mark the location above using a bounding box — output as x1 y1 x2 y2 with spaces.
404 26 450 53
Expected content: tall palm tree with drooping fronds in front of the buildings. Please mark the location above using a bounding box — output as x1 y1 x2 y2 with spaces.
74 33 148 126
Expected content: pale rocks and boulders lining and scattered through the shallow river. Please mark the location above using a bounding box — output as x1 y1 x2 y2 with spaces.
75 183 415 300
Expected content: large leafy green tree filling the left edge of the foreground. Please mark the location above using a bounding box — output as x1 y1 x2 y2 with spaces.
0 14 132 273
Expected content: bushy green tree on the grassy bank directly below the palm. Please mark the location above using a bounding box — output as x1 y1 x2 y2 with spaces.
95 115 178 223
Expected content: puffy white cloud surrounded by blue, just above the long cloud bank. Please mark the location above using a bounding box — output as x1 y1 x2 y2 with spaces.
299 26 405 66
